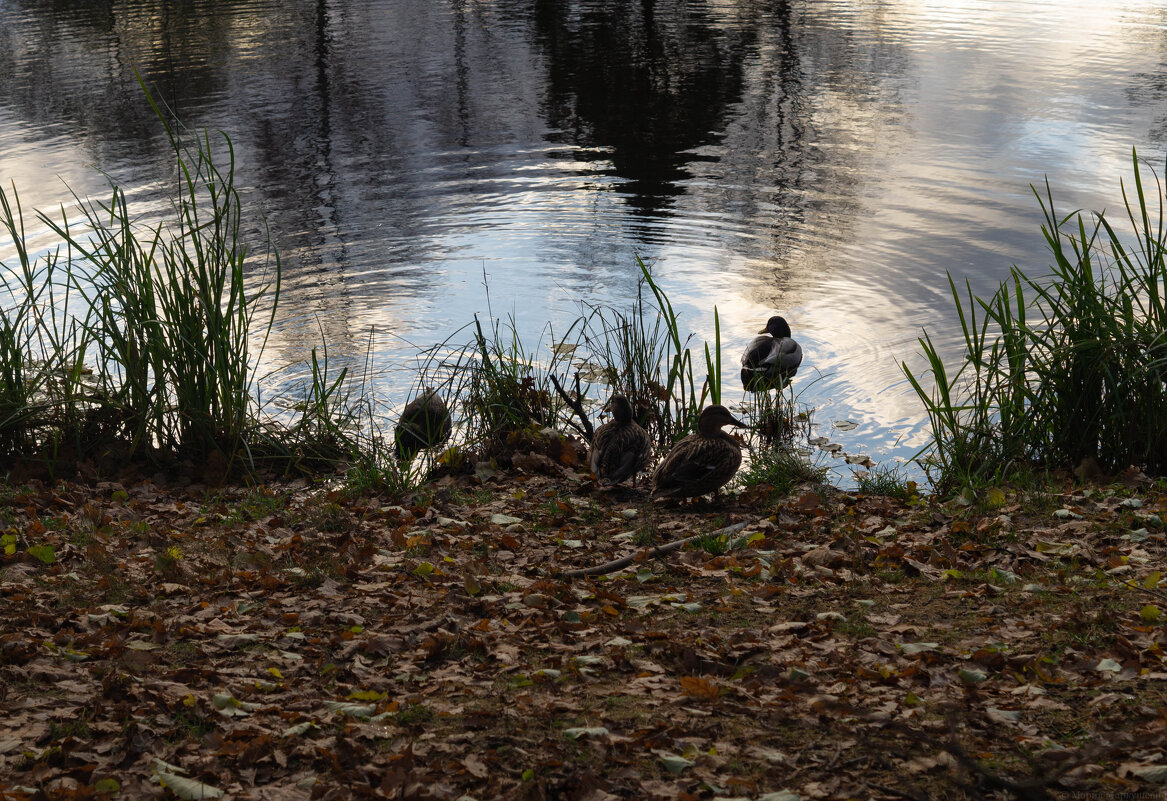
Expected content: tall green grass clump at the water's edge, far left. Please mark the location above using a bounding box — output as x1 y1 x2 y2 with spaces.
0 86 354 469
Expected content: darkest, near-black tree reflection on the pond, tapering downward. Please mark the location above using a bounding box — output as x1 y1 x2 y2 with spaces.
534 0 742 210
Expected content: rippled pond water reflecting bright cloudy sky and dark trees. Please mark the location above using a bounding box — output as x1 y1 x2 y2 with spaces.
0 0 1167 481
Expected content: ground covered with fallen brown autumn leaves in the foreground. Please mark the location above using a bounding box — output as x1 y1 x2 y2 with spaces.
0 468 1167 801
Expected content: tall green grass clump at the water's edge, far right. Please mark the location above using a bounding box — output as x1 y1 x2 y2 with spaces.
902 152 1167 492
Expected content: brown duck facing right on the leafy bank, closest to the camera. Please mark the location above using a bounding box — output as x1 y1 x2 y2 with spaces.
652 405 747 497
